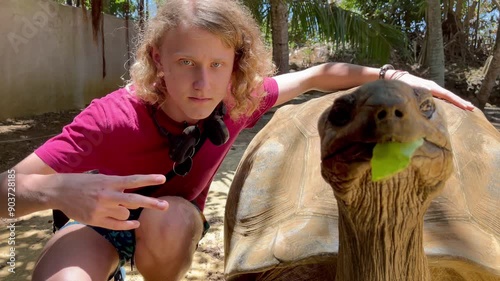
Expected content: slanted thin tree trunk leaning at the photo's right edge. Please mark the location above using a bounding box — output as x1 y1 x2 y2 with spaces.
477 19 500 110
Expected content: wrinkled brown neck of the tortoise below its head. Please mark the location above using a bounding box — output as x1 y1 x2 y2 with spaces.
336 179 431 281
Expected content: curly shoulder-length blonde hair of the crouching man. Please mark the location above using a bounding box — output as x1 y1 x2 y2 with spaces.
130 0 275 120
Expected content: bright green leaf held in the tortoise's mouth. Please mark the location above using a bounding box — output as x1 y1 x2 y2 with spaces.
371 138 424 181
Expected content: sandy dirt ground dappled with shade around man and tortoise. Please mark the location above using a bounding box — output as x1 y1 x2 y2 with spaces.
0 86 500 281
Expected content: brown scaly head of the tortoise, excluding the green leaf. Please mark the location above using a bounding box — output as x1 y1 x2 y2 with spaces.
318 80 452 204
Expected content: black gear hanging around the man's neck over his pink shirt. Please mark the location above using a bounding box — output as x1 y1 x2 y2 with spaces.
151 102 229 176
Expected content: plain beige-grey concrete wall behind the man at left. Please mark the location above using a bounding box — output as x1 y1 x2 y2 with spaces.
0 0 136 120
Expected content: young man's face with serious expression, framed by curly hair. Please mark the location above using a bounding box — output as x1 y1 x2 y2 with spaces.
153 25 234 123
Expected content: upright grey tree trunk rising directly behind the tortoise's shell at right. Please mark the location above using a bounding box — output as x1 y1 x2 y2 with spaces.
426 0 444 87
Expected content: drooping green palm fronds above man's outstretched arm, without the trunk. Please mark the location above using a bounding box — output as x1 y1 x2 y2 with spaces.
243 0 407 62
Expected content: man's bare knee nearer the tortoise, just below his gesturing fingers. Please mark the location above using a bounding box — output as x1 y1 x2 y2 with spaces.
135 197 203 280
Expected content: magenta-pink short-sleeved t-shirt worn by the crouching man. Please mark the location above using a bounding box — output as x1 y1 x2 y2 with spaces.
35 78 278 210
